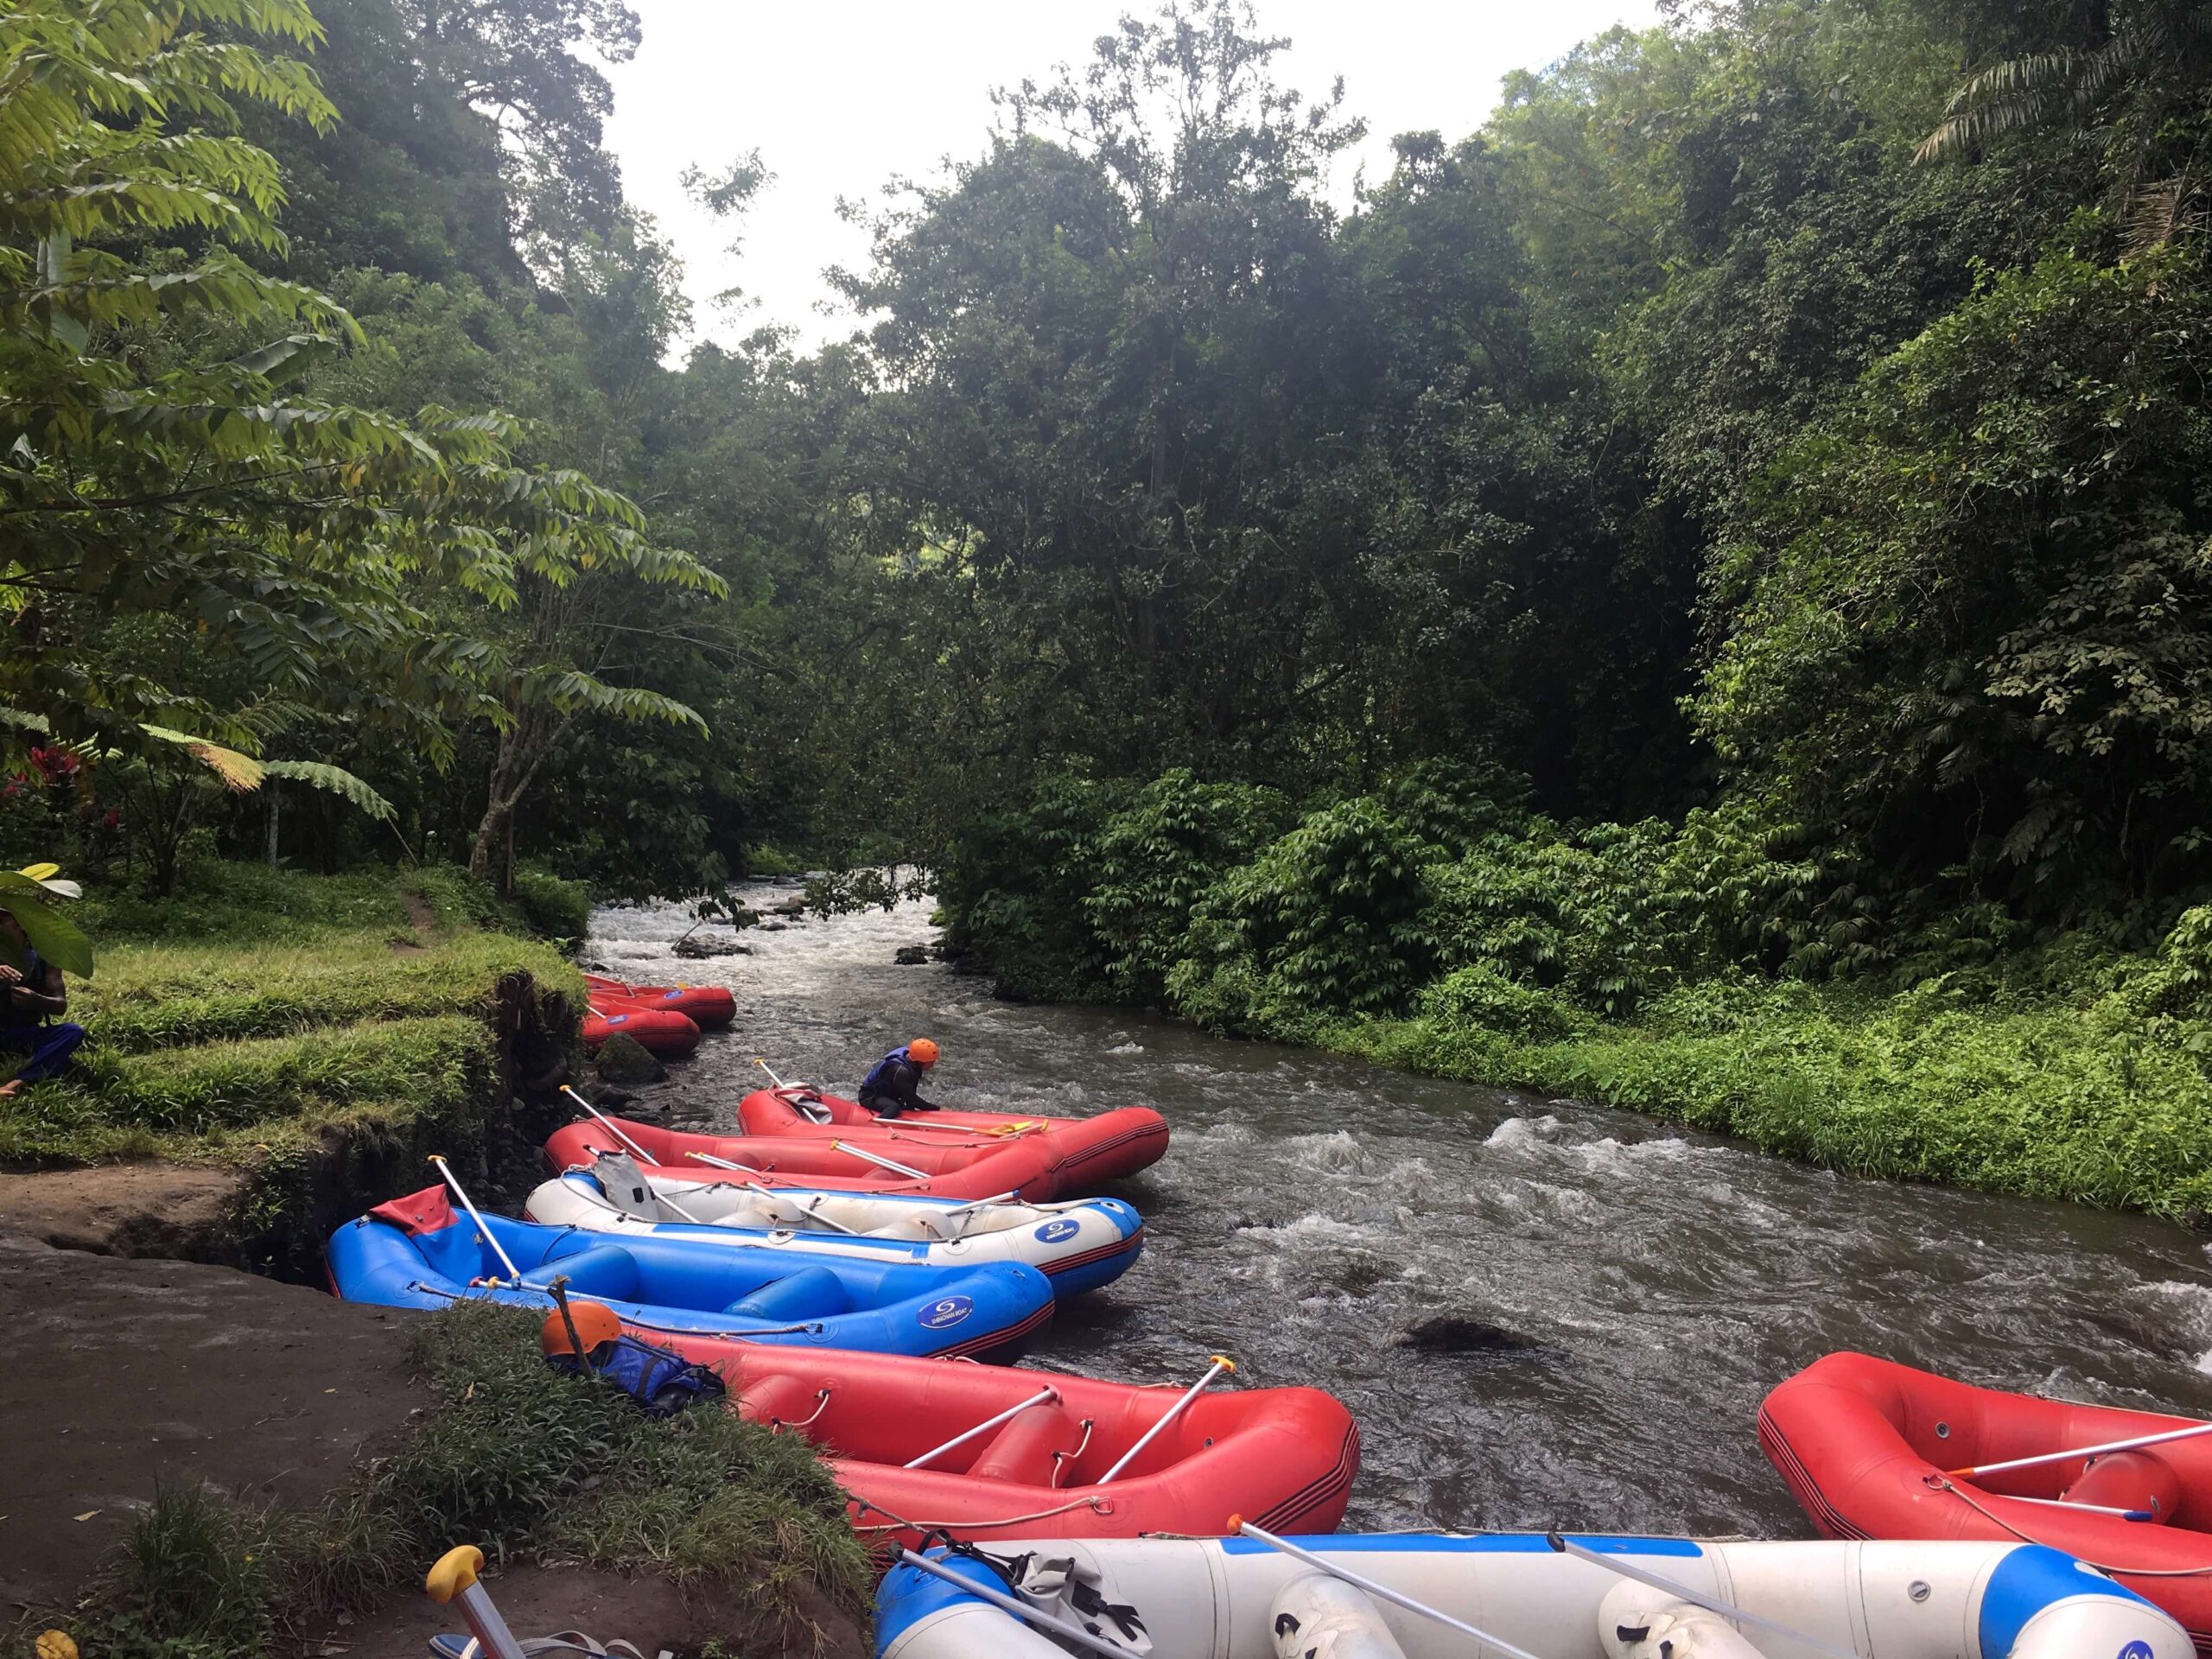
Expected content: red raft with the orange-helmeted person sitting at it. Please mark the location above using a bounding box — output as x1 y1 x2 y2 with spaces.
736 1089 1168 1194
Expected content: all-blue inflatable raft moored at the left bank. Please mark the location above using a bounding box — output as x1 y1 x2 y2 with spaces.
329 1188 1053 1356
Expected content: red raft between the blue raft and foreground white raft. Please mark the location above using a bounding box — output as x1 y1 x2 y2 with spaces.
652 1334 1360 1548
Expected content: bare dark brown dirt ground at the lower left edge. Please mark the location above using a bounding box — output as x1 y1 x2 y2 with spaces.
0 1232 427 1615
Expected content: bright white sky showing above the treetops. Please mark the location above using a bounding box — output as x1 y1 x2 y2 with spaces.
608 0 1656 345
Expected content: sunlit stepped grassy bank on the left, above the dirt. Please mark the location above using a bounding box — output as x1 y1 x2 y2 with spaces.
0 862 582 1274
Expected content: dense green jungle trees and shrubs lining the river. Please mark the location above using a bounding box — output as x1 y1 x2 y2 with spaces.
13 0 2212 1192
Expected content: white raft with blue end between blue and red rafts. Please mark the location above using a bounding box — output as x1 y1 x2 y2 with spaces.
522 1153 1144 1299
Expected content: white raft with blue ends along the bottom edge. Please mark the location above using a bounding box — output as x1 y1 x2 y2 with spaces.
876 1533 2195 1659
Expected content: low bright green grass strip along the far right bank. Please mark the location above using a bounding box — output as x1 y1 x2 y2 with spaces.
1307 982 2212 1221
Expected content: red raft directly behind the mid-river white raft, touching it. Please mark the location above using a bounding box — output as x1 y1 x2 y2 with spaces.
544 1117 1059 1204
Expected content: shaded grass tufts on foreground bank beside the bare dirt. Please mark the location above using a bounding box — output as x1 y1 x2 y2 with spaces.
42 1303 872 1659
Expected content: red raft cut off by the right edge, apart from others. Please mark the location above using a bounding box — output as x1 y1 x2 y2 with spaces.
1758 1354 2212 1655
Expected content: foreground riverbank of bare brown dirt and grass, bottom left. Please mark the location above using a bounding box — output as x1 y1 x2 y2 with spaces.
0 1234 869 1659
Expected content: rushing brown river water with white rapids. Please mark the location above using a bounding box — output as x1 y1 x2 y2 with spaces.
588 885 2212 1535
